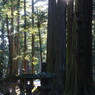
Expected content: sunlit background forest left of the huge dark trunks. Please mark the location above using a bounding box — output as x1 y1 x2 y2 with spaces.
0 0 47 74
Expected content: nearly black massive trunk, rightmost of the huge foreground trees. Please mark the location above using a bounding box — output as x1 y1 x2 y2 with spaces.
75 0 92 95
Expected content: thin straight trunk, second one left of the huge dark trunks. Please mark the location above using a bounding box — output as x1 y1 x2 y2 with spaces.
32 0 35 73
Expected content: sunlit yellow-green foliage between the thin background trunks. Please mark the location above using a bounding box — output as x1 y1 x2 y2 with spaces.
0 0 47 75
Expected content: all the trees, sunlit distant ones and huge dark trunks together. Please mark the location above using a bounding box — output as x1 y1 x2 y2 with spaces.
0 0 95 95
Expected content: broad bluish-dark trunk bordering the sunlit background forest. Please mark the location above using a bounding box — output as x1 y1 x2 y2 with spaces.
47 0 66 95
